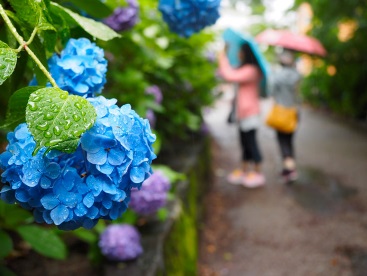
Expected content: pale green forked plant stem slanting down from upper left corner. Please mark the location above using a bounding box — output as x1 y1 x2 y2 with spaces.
0 4 58 87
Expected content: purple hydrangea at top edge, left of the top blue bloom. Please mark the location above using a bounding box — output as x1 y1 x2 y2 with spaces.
103 0 139 32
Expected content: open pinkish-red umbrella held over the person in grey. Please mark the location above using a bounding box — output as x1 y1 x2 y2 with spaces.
255 29 326 56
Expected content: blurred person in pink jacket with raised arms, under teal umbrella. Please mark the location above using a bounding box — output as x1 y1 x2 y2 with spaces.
218 44 265 188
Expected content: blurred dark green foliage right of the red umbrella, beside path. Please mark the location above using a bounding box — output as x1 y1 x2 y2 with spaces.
296 0 367 120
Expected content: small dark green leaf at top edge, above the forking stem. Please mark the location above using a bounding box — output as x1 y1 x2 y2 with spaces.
9 0 42 27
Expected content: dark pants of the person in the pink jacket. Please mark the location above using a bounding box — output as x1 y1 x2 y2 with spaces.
240 129 262 163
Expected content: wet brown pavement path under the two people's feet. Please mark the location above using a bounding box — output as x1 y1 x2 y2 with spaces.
199 89 367 276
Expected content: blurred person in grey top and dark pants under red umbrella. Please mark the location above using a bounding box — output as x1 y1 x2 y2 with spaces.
270 49 301 183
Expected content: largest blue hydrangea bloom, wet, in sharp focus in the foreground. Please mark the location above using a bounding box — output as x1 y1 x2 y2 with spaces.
0 96 156 230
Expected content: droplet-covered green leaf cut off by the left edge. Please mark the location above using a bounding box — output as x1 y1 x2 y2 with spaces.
0 41 17 85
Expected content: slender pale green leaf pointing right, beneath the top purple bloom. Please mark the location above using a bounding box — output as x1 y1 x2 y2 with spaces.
51 2 120 41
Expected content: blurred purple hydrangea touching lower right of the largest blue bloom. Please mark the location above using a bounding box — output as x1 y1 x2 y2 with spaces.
129 171 171 215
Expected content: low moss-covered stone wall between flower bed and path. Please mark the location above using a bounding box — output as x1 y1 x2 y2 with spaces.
103 133 211 276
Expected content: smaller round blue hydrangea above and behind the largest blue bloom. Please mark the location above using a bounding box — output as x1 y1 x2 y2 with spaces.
41 38 107 97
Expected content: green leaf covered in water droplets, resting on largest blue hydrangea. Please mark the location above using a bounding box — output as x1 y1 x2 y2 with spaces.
26 88 97 153
